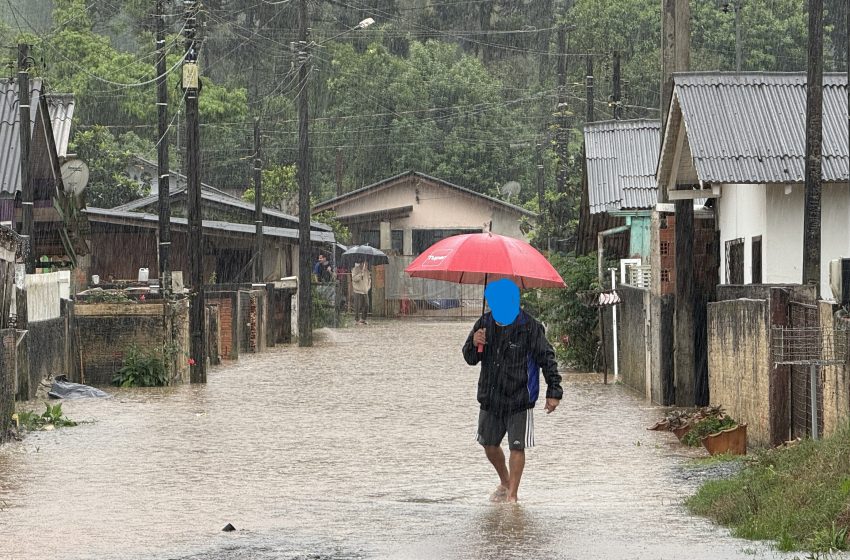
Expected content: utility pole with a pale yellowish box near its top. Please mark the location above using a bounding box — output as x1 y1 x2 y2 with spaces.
183 0 207 383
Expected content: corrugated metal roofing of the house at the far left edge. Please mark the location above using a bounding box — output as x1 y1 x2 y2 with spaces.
0 78 74 194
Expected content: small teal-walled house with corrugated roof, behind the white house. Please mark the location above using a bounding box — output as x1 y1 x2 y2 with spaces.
578 119 661 285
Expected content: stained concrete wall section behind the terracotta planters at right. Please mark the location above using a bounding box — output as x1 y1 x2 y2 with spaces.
708 299 771 446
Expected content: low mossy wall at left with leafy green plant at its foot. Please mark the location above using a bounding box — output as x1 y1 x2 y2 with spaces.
74 300 189 385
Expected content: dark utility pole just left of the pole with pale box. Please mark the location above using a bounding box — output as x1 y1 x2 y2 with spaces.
156 0 171 297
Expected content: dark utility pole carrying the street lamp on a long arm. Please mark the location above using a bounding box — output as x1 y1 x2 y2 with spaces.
297 0 313 346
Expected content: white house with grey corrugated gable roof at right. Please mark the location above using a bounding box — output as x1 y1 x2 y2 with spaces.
658 72 850 297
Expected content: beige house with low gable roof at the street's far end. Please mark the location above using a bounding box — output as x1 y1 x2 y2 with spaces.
314 171 536 255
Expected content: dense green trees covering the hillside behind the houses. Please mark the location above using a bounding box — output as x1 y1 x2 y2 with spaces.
0 0 847 243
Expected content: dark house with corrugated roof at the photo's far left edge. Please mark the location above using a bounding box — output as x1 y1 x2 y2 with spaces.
0 79 88 267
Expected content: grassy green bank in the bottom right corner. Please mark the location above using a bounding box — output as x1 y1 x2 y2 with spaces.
686 426 850 552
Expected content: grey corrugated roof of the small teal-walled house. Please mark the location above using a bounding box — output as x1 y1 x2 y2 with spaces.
584 119 661 214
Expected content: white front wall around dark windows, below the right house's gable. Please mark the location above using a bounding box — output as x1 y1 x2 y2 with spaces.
717 184 768 284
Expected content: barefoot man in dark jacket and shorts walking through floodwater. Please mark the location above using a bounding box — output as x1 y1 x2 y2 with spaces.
463 279 563 502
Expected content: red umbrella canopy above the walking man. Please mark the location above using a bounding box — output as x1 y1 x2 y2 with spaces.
405 233 566 289
